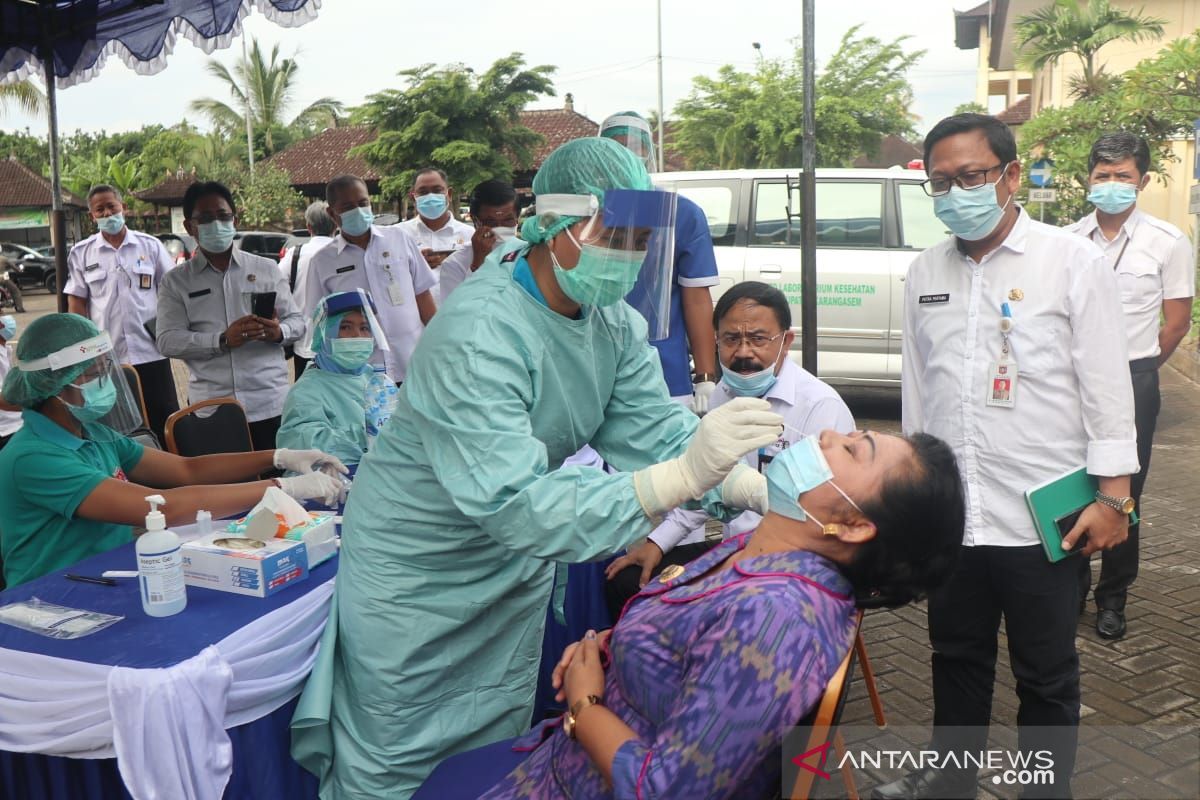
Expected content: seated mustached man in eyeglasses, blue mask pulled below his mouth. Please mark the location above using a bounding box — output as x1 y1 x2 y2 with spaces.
605 281 854 619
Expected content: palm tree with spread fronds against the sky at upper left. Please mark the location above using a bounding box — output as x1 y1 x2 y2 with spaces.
191 40 343 155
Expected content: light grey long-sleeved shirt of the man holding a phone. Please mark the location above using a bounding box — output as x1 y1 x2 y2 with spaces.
158 248 305 422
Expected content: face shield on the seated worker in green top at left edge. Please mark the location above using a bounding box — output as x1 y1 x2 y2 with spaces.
16 333 143 434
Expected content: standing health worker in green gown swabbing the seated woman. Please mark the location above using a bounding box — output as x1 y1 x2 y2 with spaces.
293 138 782 800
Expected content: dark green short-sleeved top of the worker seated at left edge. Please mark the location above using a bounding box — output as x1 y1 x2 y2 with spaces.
0 409 143 587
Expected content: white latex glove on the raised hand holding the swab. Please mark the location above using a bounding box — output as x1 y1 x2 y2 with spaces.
634 397 784 517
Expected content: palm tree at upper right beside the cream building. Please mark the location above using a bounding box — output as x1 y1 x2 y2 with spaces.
1016 0 1166 97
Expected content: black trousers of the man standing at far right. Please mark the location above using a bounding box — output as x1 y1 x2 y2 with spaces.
1079 357 1163 612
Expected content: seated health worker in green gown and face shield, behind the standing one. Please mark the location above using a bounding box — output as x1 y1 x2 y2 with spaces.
275 289 397 464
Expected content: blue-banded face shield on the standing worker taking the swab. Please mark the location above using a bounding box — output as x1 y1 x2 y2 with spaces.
538 190 676 339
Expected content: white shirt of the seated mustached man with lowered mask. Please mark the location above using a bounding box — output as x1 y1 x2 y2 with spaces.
649 359 854 553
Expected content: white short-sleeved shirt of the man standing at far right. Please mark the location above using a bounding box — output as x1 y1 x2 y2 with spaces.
1067 209 1196 360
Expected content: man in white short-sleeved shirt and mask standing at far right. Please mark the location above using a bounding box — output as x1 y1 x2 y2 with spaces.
1067 132 1196 639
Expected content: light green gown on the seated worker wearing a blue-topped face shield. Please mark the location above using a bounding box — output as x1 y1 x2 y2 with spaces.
275 366 367 464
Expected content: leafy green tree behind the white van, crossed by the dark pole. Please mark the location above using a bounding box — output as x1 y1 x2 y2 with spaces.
674 25 924 169
